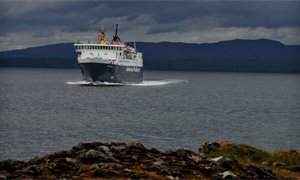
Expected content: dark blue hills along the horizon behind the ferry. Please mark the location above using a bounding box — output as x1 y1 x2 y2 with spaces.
0 39 300 73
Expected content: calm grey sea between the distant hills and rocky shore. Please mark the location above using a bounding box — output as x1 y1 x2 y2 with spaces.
0 68 300 160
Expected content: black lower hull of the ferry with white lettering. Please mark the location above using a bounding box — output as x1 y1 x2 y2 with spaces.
79 63 143 83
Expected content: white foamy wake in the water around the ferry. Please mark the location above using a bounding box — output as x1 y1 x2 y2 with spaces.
66 79 188 86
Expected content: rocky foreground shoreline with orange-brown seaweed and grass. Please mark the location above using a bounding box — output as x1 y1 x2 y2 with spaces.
0 140 300 179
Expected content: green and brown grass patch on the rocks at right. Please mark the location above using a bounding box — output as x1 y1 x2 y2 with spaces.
207 141 300 179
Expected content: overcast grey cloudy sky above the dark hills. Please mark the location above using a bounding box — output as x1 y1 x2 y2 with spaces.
0 0 300 51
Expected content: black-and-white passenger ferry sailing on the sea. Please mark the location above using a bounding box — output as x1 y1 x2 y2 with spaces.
74 24 143 83
